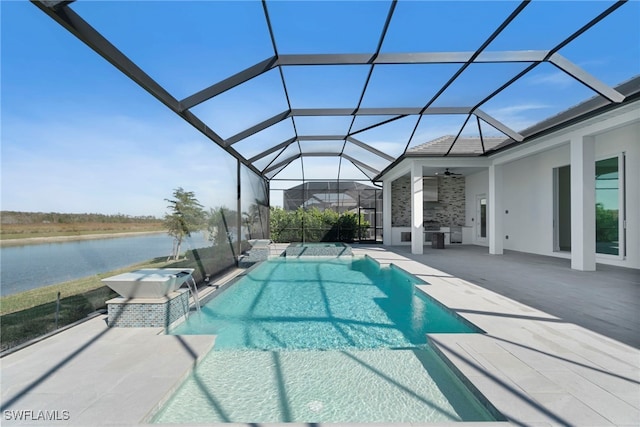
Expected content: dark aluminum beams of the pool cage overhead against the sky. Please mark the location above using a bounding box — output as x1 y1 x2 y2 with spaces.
32 0 626 186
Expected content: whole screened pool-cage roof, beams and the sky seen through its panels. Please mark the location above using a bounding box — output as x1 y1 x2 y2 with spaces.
33 0 640 184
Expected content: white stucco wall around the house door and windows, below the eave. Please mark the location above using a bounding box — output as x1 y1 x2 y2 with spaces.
465 118 640 268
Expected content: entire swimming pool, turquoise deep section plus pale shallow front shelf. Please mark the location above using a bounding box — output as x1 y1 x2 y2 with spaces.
153 258 499 423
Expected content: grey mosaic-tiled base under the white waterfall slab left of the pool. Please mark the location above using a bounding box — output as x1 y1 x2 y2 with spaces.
107 289 189 328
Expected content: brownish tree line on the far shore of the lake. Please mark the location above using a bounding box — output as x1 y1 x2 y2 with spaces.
0 211 160 224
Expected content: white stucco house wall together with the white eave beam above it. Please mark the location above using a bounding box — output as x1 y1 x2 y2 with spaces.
385 101 640 269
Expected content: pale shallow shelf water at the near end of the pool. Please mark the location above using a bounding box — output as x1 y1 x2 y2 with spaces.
154 349 494 424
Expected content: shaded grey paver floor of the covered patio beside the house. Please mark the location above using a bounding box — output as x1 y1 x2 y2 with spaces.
384 245 640 348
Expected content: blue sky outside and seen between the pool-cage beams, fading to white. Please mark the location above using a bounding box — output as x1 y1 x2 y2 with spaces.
0 0 640 216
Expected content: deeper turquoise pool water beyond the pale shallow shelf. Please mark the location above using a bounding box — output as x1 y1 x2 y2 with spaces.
172 258 478 350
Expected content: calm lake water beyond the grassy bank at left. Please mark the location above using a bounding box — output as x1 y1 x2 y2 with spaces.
0 233 209 296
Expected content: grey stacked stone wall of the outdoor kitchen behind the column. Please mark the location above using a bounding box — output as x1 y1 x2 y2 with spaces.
391 175 466 227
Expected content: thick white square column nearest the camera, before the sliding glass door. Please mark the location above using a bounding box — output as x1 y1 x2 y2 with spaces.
571 136 596 271
